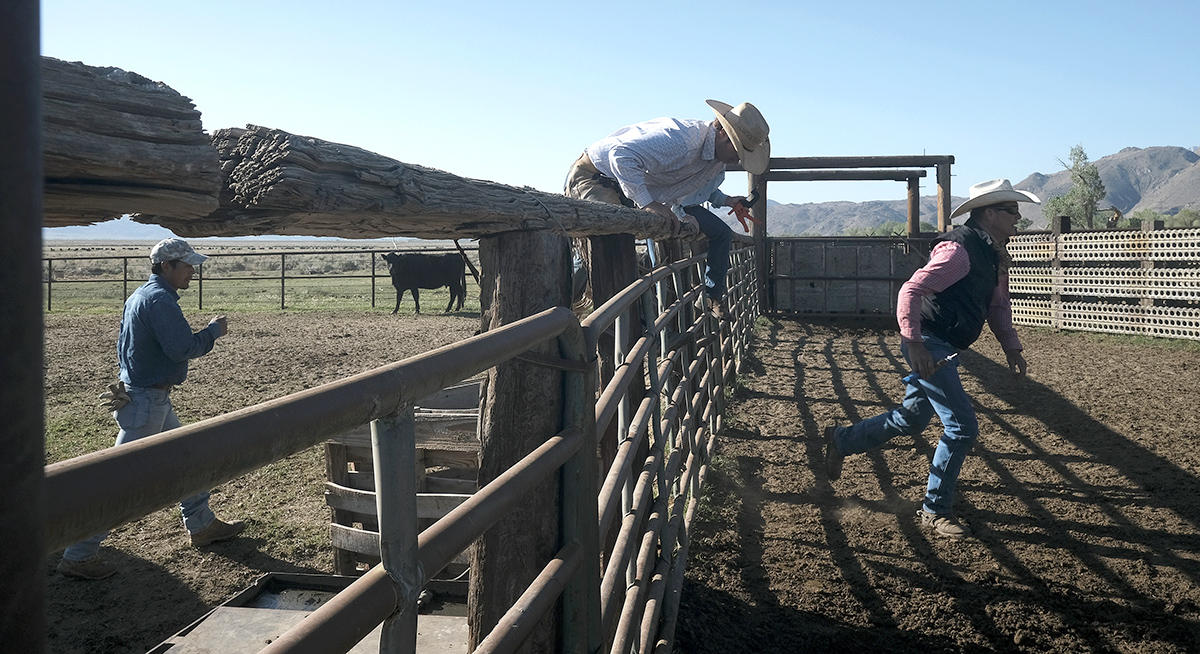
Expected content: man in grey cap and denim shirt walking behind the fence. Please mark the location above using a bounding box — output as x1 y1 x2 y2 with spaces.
58 239 245 580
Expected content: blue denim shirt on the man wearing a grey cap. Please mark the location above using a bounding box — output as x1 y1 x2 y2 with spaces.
116 275 220 386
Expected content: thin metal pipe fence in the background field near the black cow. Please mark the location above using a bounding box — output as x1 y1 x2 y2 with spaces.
42 246 479 311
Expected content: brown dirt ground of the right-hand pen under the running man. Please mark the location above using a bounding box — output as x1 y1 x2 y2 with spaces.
677 320 1200 654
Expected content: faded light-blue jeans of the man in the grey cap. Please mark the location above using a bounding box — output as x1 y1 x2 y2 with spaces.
62 386 216 560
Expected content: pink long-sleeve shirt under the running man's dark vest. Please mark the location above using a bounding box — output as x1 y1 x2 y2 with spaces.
896 241 1022 352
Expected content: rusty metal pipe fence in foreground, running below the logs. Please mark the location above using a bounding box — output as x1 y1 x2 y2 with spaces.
44 241 761 654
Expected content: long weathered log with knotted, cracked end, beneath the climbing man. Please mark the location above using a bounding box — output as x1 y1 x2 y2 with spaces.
134 125 691 239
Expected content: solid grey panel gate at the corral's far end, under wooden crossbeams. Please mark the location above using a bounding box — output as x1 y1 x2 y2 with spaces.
772 238 925 314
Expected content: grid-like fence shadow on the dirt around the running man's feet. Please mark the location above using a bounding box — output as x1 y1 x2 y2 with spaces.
680 320 1200 652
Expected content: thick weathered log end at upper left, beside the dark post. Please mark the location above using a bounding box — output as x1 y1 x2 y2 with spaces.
42 56 221 227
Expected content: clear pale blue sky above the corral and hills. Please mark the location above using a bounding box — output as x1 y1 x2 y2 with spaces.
42 0 1200 208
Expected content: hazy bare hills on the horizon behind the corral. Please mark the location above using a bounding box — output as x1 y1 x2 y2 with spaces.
767 146 1200 236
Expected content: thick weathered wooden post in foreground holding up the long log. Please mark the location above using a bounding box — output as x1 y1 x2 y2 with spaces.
468 232 571 652
